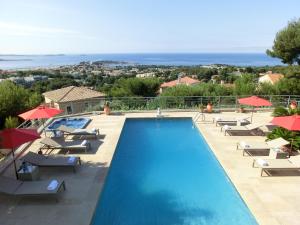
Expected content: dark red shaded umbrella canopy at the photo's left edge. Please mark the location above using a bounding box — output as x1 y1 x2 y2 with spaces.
0 128 41 148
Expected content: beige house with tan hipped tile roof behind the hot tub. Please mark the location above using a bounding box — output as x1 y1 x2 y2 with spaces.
43 86 105 114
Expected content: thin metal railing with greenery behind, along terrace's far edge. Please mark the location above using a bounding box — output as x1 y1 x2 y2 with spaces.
82 95 300 113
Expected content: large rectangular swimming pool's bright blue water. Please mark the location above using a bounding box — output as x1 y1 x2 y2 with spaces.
92 119 257 225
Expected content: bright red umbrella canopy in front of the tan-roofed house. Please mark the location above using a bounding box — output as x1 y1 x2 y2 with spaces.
19 106 63 120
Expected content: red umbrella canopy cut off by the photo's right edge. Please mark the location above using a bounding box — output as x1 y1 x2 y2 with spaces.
271 115 300 131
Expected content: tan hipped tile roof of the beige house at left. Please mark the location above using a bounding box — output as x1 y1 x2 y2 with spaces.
43 86 105 103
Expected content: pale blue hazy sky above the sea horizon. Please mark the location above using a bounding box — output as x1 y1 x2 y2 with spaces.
0 0 300 54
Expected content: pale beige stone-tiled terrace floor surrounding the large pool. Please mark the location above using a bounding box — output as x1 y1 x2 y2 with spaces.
0 112 300 225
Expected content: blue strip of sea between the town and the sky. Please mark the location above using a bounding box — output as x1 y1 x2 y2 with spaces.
0 53 282 70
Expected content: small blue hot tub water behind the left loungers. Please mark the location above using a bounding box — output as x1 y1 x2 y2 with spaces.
48 118 91 130
